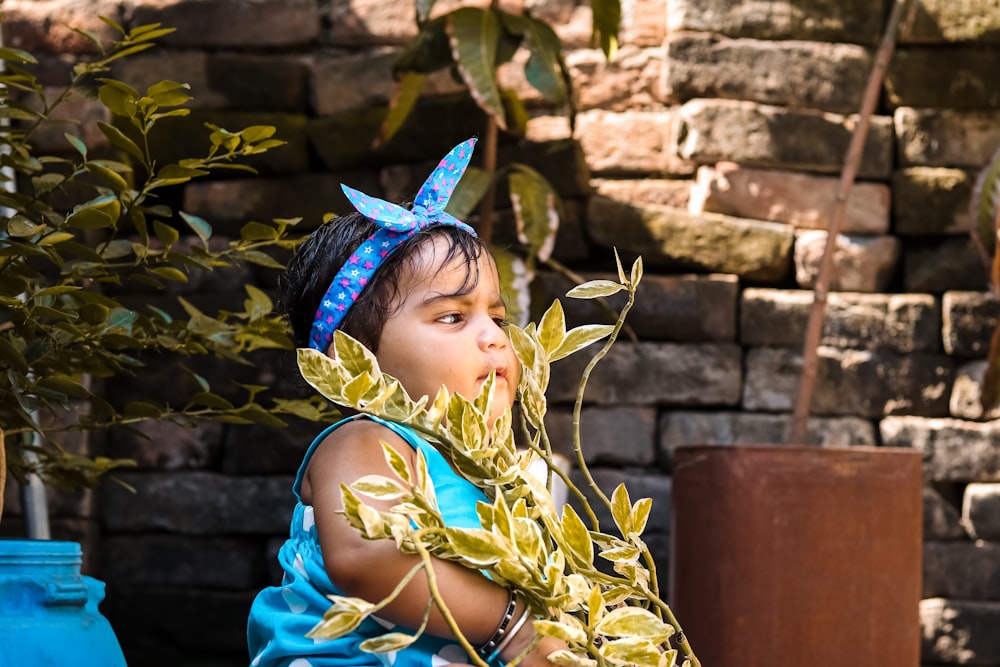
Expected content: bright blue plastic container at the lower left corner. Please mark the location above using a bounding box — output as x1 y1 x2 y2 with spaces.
0 539 125 667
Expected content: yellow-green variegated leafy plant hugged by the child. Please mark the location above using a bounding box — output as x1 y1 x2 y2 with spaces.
298 254 699 667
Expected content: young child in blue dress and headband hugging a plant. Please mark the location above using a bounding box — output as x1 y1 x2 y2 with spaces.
248 139 564 667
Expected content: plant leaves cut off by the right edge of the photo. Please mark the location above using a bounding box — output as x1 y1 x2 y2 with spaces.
969 149 1000 413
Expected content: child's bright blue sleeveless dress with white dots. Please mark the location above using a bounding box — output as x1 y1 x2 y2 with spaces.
247 415 502 667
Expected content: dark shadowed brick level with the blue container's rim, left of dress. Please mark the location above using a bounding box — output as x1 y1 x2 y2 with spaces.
101 535 264 590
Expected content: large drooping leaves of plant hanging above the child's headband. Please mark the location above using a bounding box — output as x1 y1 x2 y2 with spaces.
379 0 621 324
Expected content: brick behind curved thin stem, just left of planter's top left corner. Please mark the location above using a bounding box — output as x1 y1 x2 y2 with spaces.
545 406 656 467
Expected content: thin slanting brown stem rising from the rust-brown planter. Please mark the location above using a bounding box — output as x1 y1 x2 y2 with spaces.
788 0 907 443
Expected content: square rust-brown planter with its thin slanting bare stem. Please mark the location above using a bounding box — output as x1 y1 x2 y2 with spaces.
671 0 923 667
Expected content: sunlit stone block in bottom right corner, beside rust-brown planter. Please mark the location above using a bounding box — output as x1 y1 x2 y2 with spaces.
920 598 1000 665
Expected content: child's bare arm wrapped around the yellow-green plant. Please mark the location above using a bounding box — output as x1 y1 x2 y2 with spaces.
302 420 562 667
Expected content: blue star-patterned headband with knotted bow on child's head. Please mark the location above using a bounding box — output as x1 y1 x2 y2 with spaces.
309 138 476 352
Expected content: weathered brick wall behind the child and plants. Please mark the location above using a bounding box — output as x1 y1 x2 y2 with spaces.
0 0 1000 667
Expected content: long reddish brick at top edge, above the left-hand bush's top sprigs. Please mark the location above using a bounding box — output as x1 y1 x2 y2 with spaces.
125 0 321 49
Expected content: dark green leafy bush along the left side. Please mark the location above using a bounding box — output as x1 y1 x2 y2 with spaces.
0 19 340 510
